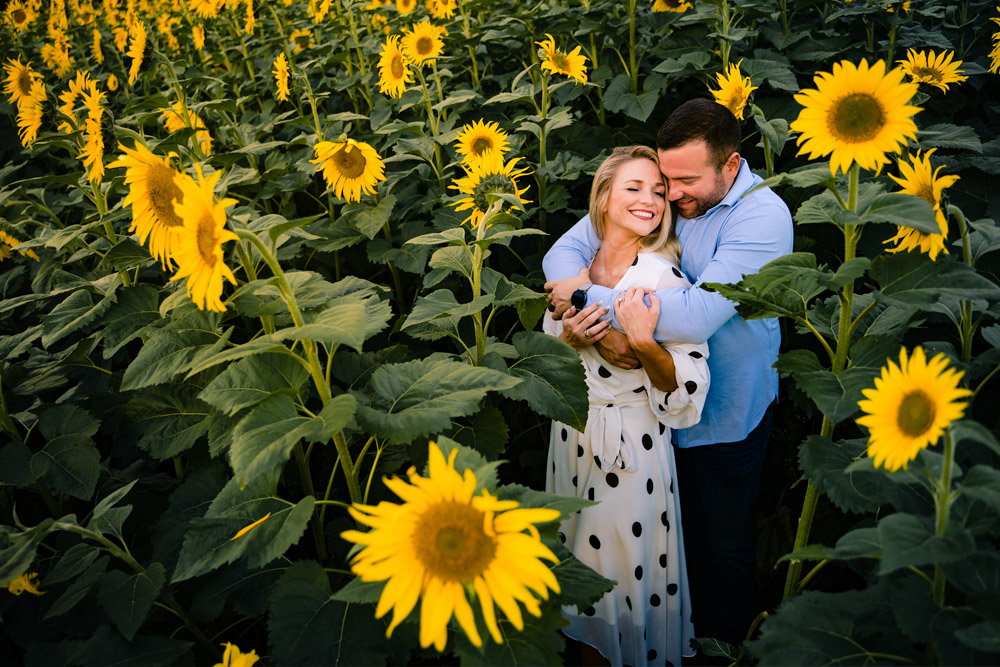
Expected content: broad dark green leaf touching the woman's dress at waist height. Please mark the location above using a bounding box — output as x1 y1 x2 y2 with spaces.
491 331 590 432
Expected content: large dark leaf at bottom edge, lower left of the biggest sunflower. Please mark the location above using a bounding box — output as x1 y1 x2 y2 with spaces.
267 561 409 665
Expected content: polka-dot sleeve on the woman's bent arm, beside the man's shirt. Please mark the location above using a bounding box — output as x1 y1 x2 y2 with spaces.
643 343 711 428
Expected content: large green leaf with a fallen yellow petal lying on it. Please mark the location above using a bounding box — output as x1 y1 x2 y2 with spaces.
172 474 315 583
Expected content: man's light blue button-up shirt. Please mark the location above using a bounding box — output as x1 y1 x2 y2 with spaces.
542 160 792 447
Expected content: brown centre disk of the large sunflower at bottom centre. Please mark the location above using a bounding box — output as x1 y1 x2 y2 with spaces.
413 501 497 583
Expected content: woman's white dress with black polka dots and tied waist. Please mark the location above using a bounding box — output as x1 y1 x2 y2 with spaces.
543 253 709 667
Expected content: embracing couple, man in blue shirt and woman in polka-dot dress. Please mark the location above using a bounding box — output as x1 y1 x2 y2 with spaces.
543 99 792 666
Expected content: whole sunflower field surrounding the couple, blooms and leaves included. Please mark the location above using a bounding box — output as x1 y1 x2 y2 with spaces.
0 0 1000 665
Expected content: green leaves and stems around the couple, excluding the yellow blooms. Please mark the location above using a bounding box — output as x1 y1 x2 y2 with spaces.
0 0 1000 665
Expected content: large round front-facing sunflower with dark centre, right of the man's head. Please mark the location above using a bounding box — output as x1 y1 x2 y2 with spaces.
790 59 920 174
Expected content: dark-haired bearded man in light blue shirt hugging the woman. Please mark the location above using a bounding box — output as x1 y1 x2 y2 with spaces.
543 99 792 644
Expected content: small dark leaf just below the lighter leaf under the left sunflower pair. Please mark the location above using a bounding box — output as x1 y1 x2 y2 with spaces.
127 384 212 461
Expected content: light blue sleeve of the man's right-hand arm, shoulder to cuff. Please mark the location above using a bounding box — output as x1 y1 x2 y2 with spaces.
587 199 792 343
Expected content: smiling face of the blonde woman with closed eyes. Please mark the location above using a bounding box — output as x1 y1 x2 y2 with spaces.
604 158 667 236
